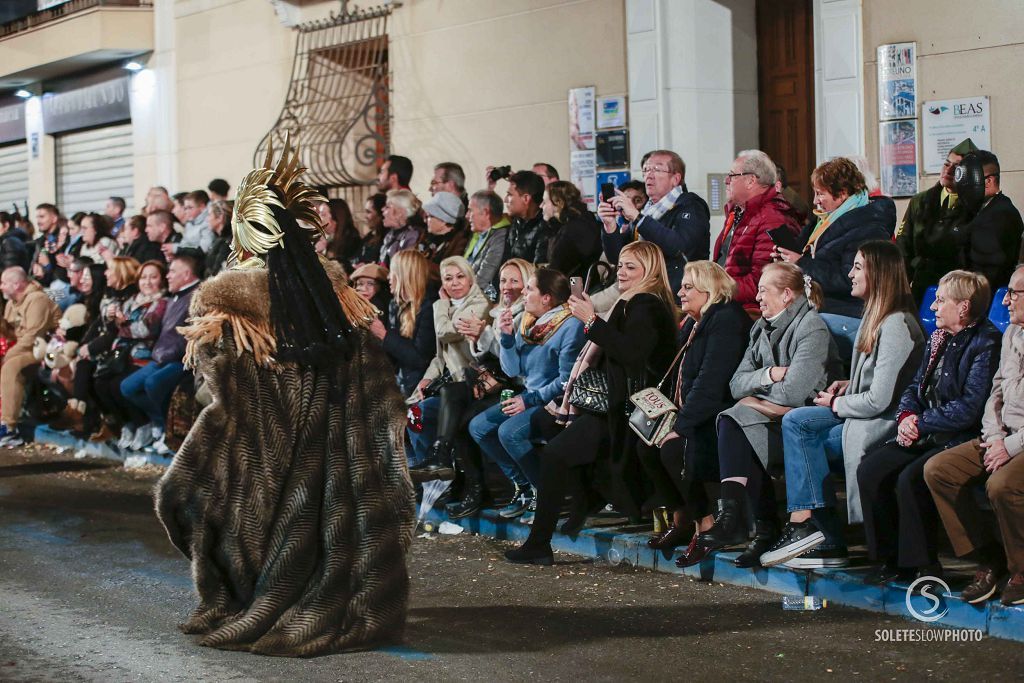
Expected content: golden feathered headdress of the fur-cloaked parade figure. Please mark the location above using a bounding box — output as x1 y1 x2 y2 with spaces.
230 133 327 267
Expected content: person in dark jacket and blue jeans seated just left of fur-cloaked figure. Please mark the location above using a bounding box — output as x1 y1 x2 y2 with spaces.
121 248 203 451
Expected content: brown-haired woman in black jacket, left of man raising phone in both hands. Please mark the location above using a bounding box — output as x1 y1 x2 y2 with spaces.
541 180 601 278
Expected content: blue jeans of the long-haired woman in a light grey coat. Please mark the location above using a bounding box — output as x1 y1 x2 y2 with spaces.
782 405 843 543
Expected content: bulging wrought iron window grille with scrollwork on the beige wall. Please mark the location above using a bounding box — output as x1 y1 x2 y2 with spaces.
254 2 395 200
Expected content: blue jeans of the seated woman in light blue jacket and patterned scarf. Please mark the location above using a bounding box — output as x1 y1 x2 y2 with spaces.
469 403 541 486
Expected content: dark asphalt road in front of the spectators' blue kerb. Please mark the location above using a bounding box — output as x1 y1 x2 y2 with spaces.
0 446 1024 683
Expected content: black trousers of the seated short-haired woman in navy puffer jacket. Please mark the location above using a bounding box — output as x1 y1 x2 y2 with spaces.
857 442 943 568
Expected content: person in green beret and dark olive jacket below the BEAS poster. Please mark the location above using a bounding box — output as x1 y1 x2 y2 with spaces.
896 137 978 303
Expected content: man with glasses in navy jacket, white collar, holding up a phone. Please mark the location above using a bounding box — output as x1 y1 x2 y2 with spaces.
597 150 711 292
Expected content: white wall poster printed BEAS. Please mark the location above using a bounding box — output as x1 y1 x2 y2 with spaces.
921 96 992 173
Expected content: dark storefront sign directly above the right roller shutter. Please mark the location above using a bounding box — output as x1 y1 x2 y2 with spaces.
42 76 131 135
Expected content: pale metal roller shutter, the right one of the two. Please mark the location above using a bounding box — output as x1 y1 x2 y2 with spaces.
56 123 135 216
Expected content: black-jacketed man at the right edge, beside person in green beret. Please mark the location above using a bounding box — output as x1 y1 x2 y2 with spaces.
963 151 1024 293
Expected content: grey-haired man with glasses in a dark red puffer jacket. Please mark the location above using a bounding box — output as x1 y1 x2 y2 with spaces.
713 150 801 317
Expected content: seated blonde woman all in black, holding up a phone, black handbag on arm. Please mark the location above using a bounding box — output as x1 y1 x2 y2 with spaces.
505 242 677 564
